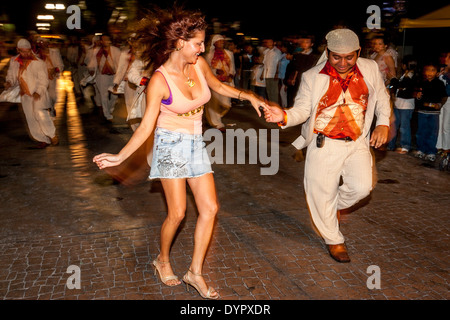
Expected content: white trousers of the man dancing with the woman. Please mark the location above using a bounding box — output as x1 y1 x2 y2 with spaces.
304 135 373 244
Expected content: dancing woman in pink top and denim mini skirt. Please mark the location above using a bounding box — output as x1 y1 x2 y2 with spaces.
94 8 266 299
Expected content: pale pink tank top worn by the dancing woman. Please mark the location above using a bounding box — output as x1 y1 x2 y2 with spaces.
156 64 211 134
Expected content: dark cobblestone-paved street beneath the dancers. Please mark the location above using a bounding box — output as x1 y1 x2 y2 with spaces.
0 83 450 300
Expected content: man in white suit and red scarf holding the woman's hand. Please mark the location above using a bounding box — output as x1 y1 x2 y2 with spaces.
265 29 391 262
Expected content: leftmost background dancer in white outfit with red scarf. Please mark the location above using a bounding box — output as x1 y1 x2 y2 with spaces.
5 39 58 149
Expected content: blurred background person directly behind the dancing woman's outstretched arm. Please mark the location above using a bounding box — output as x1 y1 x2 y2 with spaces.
205 34 236 131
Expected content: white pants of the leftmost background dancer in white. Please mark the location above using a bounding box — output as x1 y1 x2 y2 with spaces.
22 95 56 144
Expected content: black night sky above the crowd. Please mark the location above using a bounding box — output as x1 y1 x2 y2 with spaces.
0 0 450 58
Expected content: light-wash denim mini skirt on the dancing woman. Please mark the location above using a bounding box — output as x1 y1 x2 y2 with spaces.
149 128 213 179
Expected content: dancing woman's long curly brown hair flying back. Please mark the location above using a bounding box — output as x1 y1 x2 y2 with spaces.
131 5 207 74
